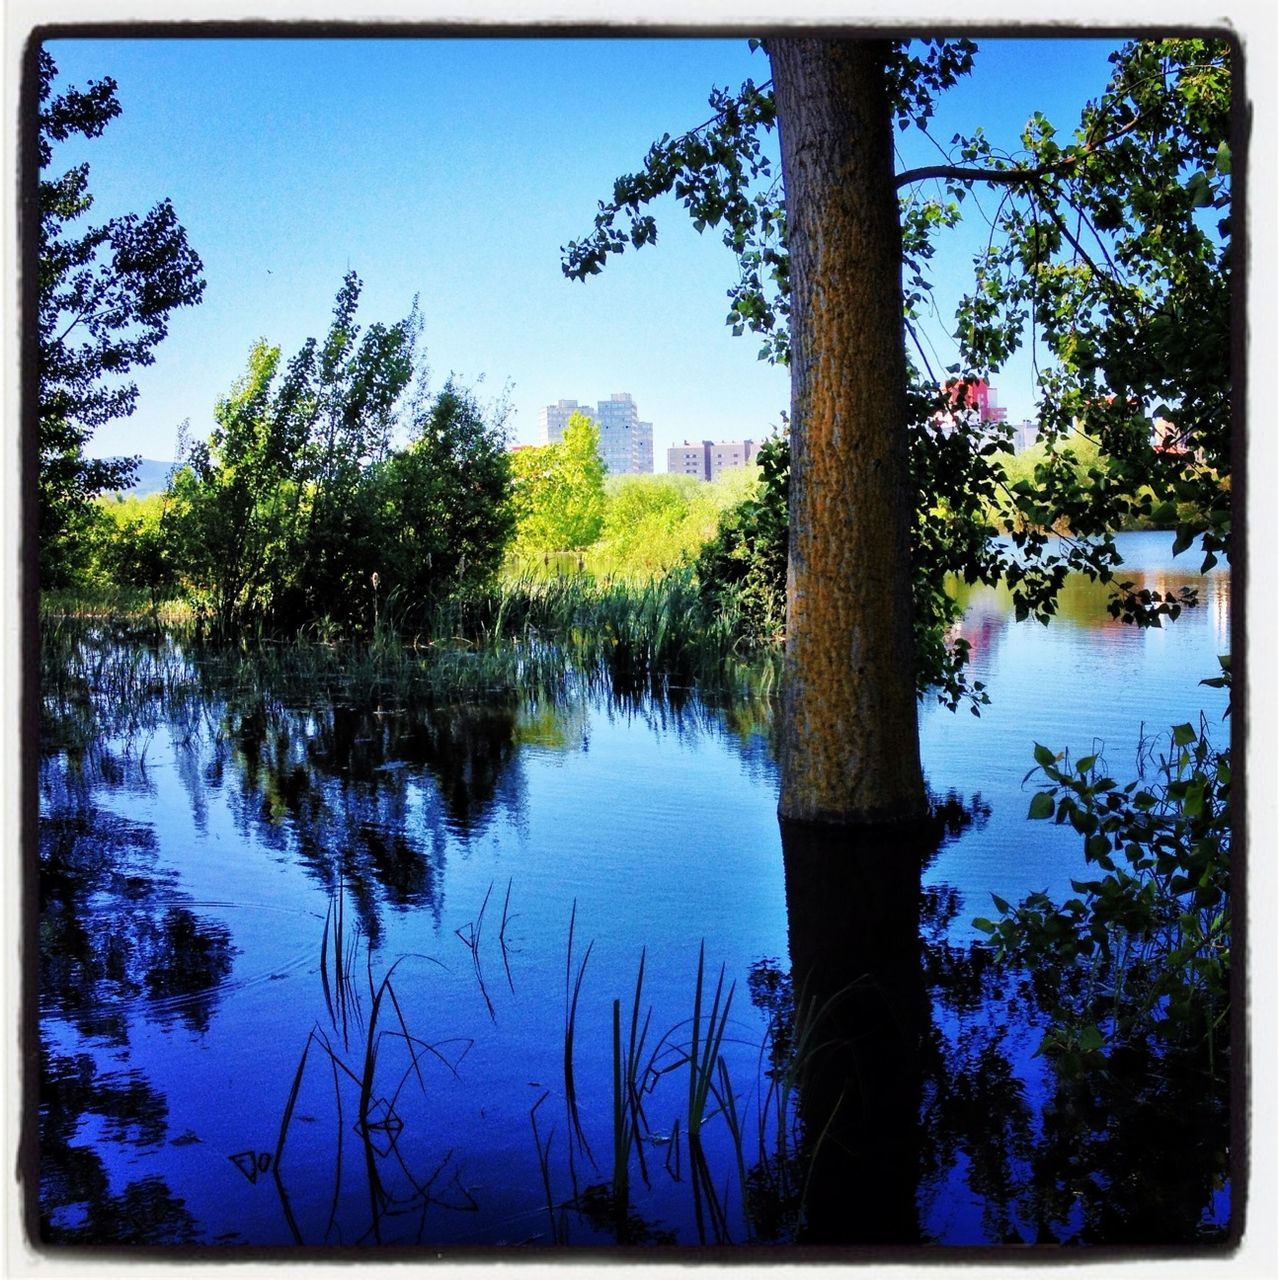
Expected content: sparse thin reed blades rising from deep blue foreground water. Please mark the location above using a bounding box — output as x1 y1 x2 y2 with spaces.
275 884 822 1244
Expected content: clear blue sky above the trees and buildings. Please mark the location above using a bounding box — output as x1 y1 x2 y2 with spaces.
49 37 1117 471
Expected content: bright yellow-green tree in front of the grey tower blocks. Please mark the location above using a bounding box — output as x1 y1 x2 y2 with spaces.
512 413 604 553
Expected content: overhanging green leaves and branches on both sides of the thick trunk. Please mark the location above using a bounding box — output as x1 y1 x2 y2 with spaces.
563 40 1231 712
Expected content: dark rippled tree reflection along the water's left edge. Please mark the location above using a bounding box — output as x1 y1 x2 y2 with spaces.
37 763 234 1244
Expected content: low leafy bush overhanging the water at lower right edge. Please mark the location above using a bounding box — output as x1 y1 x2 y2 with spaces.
974 724 1231 1073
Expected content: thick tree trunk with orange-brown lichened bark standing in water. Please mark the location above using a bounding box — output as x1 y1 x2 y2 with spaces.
769 40 925 823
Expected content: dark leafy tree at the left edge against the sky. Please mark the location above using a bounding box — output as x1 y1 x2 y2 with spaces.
36 49 205 586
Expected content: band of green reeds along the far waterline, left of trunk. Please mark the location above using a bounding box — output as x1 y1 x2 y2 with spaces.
40 555 780 748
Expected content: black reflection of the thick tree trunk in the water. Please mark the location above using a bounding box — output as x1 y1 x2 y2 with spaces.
782 822 929 1244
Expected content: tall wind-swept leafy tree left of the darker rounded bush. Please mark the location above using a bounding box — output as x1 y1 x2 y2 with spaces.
168 273 421 630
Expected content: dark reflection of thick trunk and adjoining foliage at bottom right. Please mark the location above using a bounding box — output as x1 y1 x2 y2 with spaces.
783 797 1229 1245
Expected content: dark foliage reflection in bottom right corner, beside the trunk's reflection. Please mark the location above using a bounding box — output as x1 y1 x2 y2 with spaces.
920 947 1230 1245
